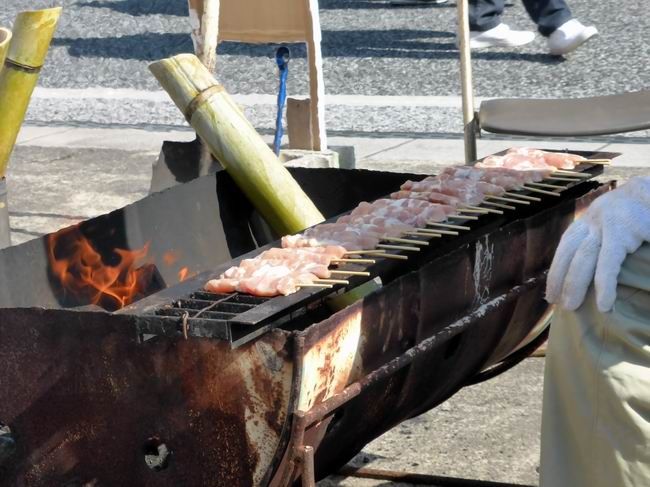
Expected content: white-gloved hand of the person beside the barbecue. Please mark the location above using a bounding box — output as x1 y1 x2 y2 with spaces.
546 177 650 312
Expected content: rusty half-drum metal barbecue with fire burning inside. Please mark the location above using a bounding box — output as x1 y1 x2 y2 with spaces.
0 153 615 486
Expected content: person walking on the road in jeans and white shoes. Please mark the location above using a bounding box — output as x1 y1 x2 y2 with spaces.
469 0 598 56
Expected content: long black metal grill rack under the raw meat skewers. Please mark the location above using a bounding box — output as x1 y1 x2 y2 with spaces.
129 153 617 347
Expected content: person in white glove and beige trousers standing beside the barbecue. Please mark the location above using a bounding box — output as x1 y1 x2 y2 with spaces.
540 177 650 487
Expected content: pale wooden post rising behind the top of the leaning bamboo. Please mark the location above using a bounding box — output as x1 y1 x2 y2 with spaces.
187 0 220 73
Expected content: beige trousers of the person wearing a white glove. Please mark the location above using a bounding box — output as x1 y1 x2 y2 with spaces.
540 243 650 487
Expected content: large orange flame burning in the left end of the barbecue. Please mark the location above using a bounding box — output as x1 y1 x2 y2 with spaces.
48 227 155 311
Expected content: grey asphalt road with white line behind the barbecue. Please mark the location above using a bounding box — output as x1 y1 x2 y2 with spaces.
0 0 650 136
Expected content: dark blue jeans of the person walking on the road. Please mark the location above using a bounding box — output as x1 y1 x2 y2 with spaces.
469 0 573 37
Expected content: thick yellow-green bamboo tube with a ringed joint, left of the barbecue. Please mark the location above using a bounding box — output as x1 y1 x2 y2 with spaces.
0 7 61 178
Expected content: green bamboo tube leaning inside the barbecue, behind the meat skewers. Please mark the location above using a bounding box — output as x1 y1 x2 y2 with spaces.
149 54 324 235
